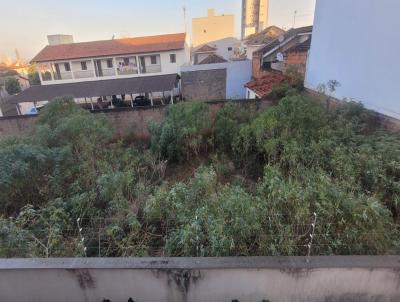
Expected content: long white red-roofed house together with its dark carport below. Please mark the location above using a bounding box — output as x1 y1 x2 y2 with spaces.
11 33 190 114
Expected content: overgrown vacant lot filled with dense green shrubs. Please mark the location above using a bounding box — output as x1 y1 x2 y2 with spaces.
0 95 400 257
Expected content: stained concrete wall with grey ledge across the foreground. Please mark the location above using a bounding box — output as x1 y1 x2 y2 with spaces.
0 257 400 302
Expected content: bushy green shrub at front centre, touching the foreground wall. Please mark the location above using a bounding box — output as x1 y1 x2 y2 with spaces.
146 168 262 256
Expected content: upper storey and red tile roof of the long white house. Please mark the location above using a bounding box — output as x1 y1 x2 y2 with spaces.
32 34 190 85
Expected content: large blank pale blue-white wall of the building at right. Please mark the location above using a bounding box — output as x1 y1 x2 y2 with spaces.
305 0 400 119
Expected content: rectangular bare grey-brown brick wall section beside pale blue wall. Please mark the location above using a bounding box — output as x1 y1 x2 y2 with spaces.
181 69 227 100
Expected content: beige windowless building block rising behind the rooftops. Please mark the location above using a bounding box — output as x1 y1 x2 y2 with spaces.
192 9 235 47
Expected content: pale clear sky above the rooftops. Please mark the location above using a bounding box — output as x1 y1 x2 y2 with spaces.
0 0 315 60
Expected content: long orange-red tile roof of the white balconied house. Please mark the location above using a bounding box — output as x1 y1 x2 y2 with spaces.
32 33 186 62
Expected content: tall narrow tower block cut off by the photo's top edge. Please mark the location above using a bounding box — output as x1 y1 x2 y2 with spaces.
242 0 269 39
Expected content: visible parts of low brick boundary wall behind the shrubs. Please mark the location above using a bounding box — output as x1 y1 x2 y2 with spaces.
0 100 272 140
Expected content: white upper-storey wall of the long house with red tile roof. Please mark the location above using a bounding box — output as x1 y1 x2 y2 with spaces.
38 48 190 85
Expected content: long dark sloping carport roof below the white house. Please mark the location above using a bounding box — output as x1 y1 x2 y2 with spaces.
7 74 179 104
